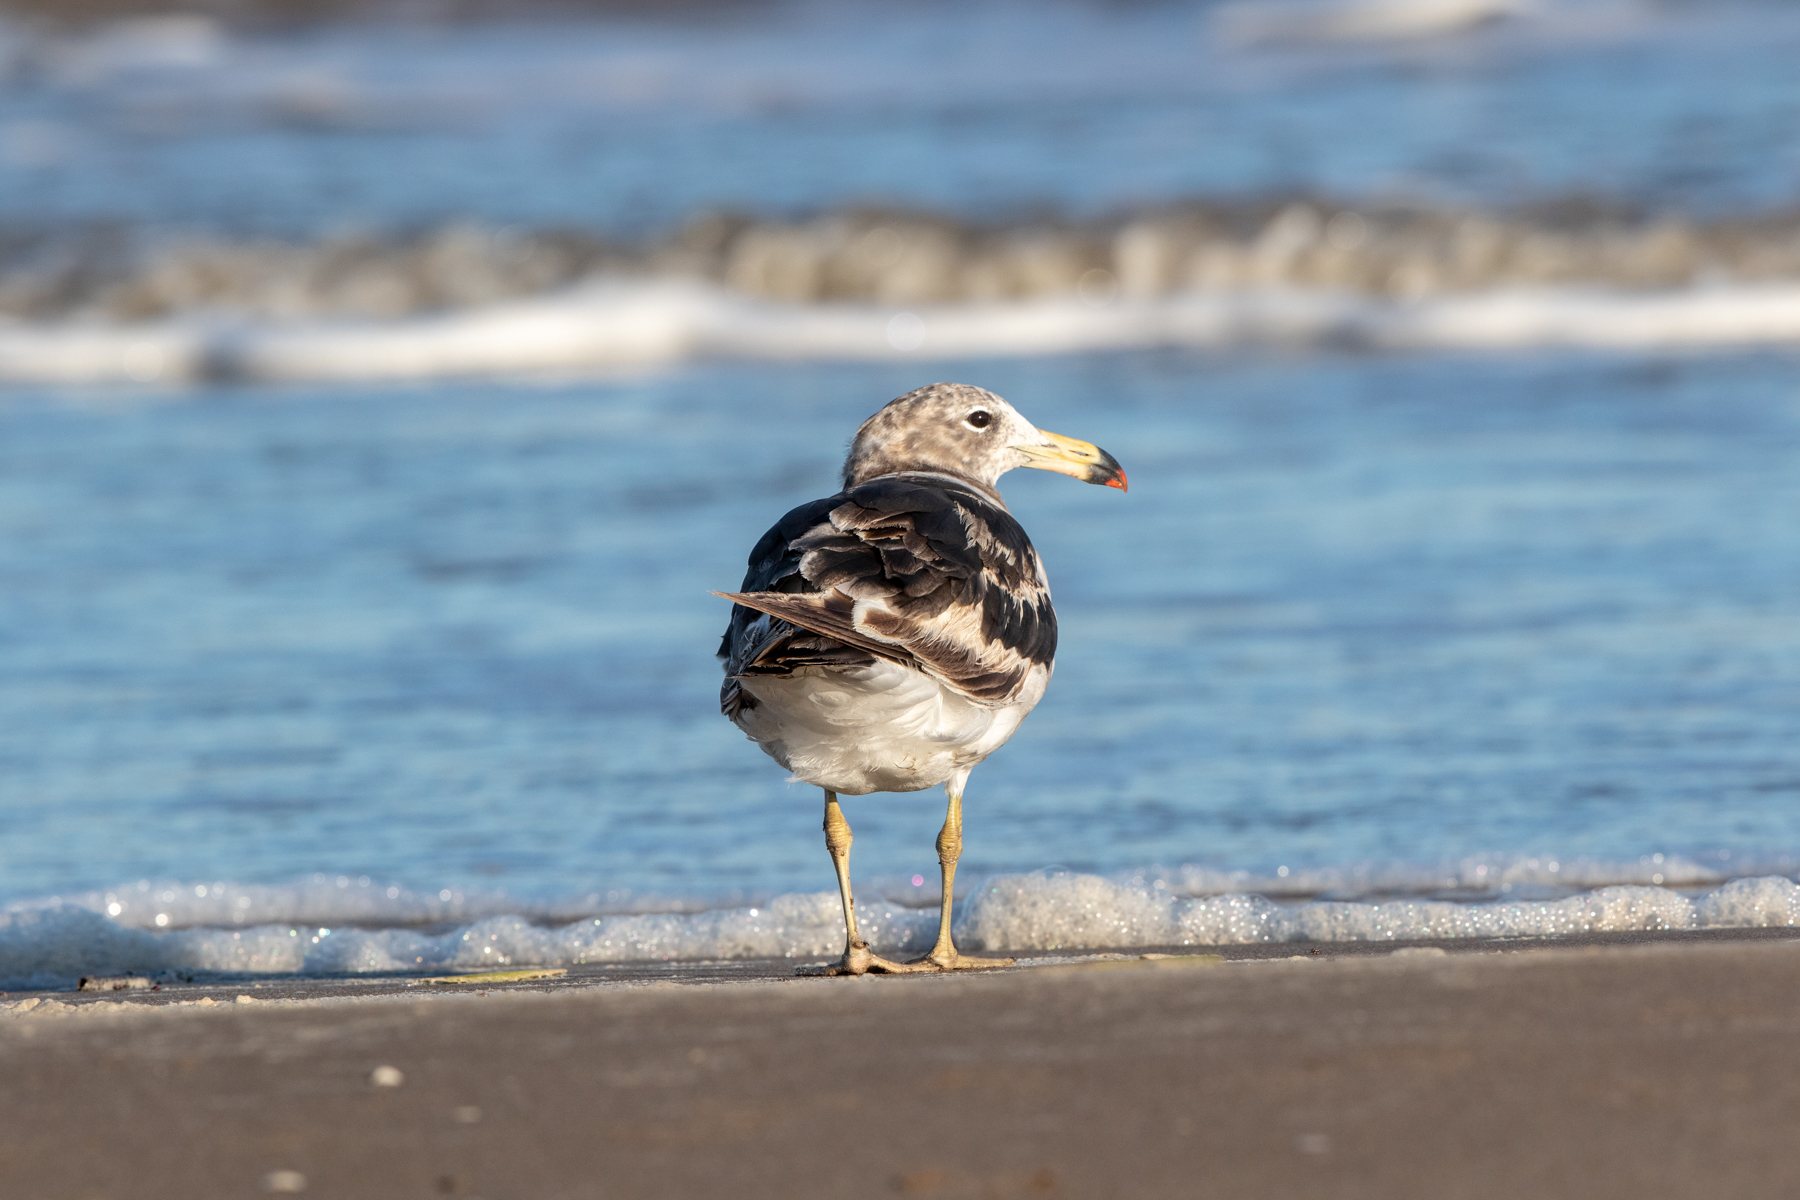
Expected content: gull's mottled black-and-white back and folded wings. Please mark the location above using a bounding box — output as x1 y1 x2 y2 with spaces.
720 475 1057 709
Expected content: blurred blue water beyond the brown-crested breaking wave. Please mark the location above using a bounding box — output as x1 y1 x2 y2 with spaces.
10 0 1800 234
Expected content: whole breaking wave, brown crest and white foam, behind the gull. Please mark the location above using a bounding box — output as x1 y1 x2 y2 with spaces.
10 201 1800 381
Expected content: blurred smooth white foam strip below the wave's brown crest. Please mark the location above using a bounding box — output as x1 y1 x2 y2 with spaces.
0 282 1800 383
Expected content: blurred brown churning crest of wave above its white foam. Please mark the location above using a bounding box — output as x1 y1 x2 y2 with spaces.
17 198 1800 322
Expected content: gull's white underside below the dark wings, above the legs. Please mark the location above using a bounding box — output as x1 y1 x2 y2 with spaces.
733 662 1049 795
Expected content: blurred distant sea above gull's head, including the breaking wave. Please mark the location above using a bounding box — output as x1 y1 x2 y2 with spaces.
10 0 1800 379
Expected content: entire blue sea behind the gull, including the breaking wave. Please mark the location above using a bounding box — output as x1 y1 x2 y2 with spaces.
0 0 1800 981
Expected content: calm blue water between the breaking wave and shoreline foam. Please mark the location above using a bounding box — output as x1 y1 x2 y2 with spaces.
0 354 1800 900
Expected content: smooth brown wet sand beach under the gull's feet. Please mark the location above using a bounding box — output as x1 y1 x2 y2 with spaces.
0 936 1800 1200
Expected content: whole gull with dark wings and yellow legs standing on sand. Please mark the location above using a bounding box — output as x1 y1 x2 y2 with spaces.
718 383 1125 975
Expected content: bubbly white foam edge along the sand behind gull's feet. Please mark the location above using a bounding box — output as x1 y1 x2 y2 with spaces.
0 856 1800 988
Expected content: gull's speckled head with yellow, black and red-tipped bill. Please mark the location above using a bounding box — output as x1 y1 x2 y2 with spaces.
844 383 1125 497
